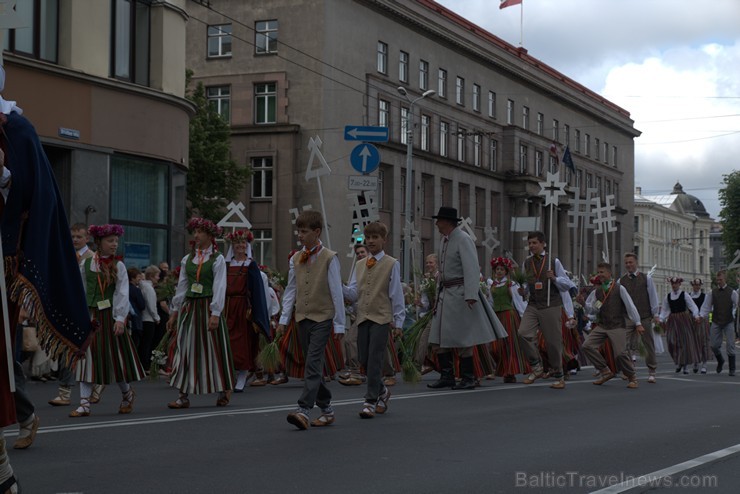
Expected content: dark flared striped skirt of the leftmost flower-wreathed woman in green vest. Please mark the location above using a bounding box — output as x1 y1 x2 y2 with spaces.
76 309 145 384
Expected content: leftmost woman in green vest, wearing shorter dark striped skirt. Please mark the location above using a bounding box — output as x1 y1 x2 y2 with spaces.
69 225 145 417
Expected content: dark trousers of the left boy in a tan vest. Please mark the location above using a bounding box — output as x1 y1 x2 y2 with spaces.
298 319 332 410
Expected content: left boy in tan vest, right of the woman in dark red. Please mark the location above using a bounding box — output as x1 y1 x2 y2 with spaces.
277 210 344 430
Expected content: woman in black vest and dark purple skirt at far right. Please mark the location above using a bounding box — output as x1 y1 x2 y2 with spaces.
660 277 700 374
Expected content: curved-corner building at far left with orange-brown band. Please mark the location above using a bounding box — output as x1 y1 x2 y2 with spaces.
2 0 194 266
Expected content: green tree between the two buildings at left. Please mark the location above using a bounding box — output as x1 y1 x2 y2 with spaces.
186 72 252 221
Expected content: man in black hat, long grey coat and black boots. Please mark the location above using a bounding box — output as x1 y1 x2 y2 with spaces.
428 206 506 389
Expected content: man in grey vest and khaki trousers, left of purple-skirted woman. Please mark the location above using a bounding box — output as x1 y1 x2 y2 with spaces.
619 252 660 384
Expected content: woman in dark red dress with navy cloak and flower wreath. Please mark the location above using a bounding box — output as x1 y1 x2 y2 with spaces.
224 230 270 392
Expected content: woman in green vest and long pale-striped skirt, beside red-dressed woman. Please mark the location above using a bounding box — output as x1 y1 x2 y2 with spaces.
167 218 234 409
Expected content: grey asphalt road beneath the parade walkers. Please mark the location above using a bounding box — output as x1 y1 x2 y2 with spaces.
6 356 740 494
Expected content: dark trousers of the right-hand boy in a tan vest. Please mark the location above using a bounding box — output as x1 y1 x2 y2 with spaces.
357 321 391 403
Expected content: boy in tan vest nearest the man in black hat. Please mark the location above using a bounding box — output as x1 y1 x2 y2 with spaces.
344 222 406 419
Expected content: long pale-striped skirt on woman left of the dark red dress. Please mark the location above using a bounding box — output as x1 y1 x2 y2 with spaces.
170 298 234 394
